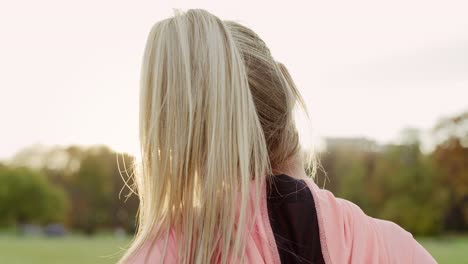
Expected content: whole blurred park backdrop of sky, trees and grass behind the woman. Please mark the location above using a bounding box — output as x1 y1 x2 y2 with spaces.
0 0 468 263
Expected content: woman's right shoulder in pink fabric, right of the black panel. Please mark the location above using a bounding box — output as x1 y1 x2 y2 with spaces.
298 176 436 263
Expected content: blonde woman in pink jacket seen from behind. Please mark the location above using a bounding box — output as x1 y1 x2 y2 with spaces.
121 10 435 264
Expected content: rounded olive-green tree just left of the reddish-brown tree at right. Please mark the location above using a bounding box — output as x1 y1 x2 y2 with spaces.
372 143 447 235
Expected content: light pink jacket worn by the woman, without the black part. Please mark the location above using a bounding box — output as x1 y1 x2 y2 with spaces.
132 179 436 264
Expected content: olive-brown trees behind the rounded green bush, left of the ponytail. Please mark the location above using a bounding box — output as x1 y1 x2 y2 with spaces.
13 146 138 233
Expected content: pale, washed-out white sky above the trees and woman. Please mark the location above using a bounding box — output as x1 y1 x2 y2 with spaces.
0 0 468 159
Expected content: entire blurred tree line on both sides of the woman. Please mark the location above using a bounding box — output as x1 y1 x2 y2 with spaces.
0 112 468 235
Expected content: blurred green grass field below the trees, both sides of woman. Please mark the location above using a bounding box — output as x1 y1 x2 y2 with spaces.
0 235 468 264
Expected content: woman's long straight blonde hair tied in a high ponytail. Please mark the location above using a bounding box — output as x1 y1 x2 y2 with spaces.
121 10 310 263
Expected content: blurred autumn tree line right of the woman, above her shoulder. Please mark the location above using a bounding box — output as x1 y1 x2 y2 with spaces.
318 112 468 235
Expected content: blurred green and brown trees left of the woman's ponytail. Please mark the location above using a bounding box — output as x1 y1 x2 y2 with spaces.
0 146 138 234
